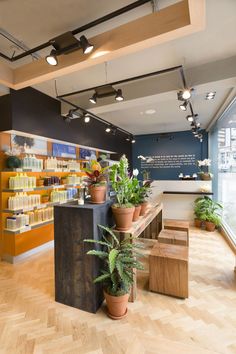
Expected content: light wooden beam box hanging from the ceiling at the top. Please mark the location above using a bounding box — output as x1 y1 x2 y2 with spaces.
0 0 205 89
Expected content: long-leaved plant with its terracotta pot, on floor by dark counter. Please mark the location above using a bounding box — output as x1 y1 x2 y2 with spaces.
84 225 143 320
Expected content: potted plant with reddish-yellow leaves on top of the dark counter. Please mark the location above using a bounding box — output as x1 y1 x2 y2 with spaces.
83 160 109 204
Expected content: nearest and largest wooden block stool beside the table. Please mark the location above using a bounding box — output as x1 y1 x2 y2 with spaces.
149 242 188 298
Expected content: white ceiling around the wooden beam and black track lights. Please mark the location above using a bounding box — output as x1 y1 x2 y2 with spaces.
0 0 236 134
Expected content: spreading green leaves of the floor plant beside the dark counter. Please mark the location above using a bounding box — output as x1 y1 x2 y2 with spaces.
84 225 143 296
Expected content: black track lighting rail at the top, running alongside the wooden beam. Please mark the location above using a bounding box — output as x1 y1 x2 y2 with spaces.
0 0 151 62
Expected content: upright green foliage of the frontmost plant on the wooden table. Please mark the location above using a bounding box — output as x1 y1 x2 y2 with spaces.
110 155 133 208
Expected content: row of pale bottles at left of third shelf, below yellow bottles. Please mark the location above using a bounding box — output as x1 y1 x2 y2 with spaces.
8 193 40 210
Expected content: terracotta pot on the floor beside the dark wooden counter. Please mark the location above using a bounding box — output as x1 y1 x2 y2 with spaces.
104 291 129 320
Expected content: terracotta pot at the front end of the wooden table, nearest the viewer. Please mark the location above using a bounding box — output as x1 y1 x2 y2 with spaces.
112 206 135 231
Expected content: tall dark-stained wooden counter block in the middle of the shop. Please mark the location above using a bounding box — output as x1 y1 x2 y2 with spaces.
54 202 112 313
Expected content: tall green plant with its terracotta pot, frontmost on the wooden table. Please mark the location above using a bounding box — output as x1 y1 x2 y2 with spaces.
110 155 135 231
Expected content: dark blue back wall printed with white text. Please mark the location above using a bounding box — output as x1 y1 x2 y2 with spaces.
133 131 208 180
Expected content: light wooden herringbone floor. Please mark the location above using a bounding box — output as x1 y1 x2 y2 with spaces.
0 229 236 354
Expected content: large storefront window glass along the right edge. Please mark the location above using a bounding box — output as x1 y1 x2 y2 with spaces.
210 99 236 242
